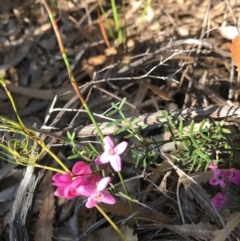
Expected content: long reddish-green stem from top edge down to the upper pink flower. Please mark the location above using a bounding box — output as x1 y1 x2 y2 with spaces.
43 0 103 140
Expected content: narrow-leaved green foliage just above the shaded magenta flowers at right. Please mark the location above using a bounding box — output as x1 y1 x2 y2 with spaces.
163 112 232 171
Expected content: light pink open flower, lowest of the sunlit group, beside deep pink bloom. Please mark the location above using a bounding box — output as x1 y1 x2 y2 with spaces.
80 177 116 208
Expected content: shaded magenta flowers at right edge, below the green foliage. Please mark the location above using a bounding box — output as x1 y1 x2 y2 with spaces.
209 163 240 210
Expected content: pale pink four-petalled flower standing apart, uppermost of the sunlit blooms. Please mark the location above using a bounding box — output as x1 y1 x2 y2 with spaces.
95 136 128 172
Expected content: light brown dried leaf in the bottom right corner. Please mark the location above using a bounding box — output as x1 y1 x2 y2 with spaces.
213 212 240 241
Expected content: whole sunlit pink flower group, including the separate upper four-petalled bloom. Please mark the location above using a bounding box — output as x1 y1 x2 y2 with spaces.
52 136 128 208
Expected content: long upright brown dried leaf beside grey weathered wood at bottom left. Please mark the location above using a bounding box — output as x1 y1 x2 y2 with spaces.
35 171 54 241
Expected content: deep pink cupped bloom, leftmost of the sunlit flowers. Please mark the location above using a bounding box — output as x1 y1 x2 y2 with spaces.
52 161 99 199
